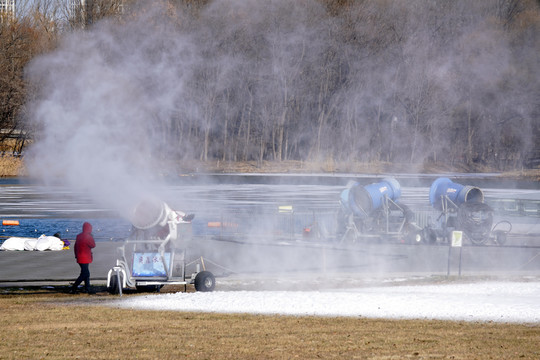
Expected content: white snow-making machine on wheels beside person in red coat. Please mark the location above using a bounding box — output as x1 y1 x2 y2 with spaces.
107 199 215 295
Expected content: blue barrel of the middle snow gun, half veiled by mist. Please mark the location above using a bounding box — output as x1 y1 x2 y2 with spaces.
340 178 401 218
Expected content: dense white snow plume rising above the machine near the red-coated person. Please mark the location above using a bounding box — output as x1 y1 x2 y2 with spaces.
27 2 198 217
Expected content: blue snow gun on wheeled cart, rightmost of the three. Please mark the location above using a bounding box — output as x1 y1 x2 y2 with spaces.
420 177 512 245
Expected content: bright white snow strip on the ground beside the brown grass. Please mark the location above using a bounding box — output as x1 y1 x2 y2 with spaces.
112 276 540 324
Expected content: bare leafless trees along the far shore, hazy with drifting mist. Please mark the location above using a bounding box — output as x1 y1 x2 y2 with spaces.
0 0 540 170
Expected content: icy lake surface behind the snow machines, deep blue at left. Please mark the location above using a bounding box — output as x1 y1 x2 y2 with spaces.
0 176 540 241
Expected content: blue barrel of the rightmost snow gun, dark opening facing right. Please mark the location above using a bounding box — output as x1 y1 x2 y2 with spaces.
429 178 484 210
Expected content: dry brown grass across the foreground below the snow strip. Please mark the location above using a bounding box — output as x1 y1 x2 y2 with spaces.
0 290 540 359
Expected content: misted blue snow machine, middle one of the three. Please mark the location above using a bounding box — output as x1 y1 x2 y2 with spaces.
337 178 421 243
